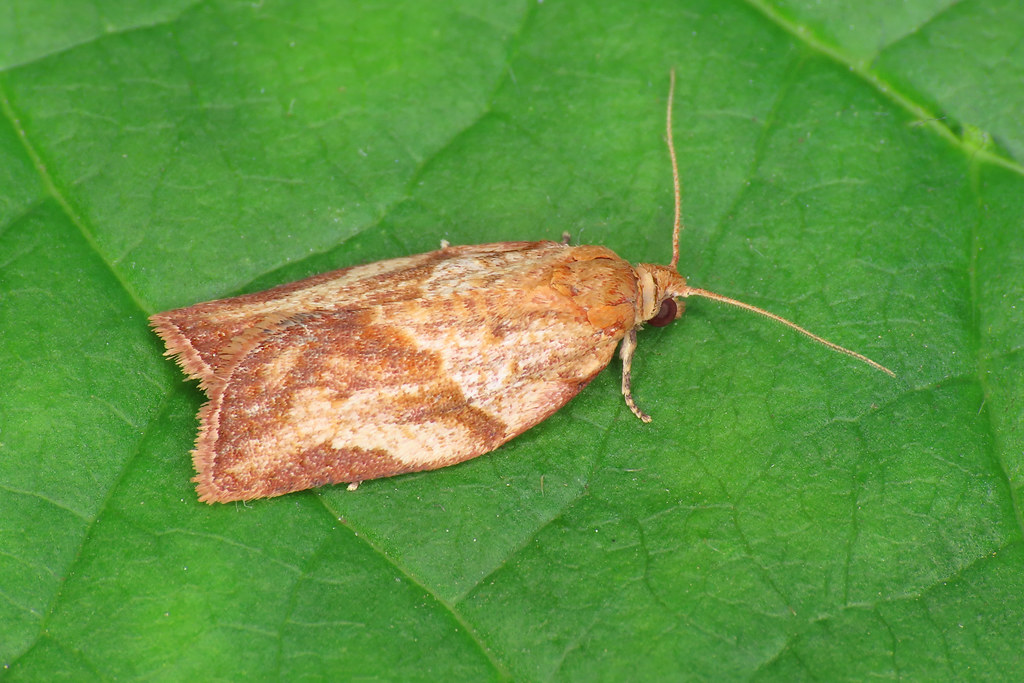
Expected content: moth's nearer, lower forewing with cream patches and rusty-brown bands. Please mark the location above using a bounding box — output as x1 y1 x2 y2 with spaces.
195 305 616 501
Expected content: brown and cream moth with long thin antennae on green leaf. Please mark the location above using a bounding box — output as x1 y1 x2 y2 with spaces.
151 74 893 503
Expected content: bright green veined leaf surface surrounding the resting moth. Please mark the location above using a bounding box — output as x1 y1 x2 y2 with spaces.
0 0 1024 680
